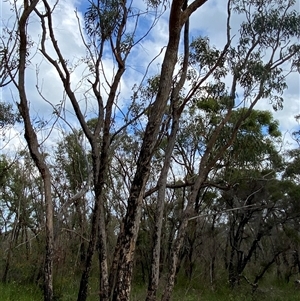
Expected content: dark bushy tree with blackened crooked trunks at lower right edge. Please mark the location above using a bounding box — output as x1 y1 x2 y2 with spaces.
222 172 299 290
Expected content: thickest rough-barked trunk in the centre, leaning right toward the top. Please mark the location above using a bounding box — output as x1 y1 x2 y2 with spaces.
113 1 183 301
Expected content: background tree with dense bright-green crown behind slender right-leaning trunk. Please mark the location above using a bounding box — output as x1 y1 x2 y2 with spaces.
163 108 283 285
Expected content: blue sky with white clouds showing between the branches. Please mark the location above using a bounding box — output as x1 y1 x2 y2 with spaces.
0 0 300 152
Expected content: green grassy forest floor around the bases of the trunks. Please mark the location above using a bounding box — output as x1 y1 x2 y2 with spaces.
0 283 300 301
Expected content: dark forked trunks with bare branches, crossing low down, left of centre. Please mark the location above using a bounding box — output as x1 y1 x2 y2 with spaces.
35 0 129 301
